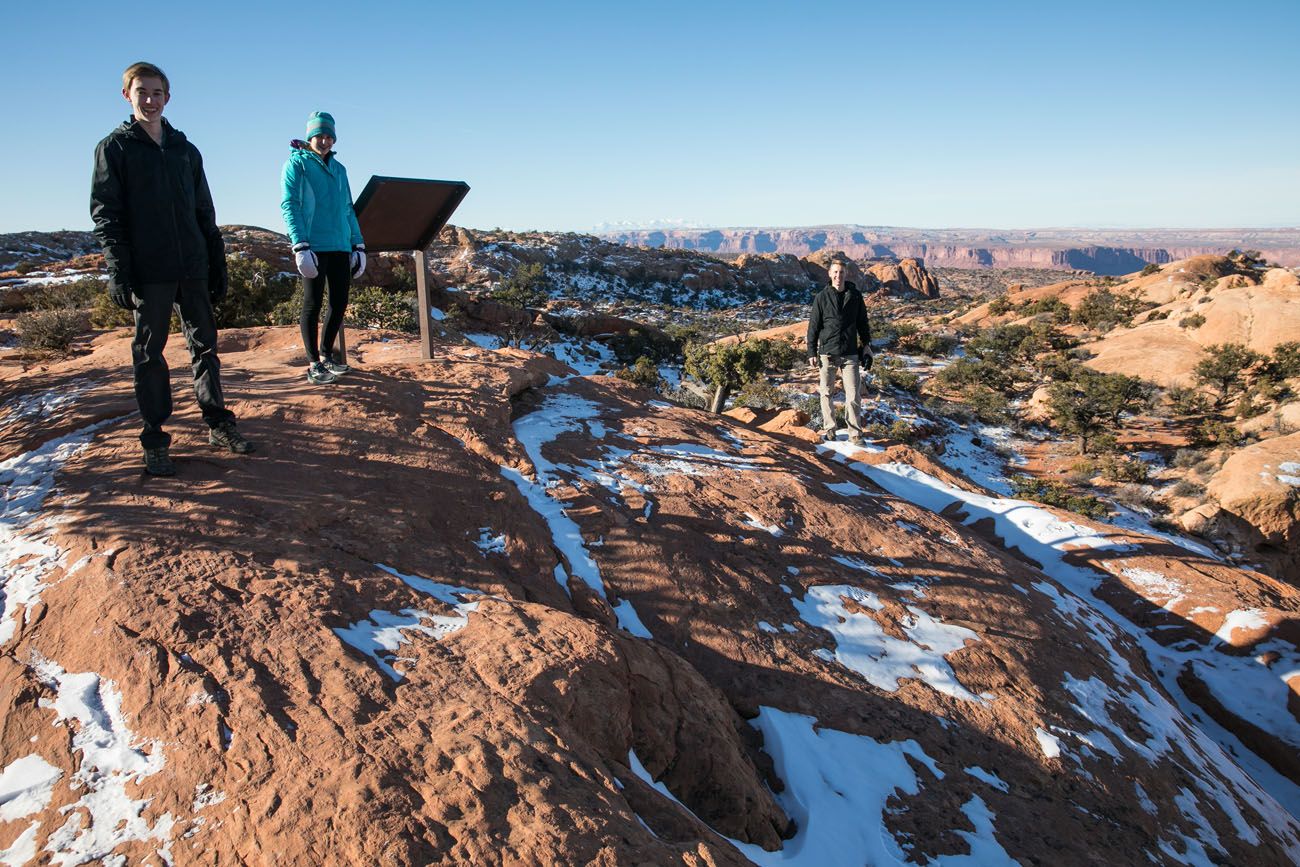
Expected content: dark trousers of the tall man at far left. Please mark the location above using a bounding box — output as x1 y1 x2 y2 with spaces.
131 279 235 448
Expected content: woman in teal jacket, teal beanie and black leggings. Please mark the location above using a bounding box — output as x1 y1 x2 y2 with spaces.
280 112 365 383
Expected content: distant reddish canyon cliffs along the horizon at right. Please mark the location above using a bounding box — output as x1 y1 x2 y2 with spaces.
603 227 1300 274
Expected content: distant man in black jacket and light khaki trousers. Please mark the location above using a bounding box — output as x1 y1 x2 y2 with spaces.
807 261 871 446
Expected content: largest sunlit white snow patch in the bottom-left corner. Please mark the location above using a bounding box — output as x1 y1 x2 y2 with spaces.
33 658 176 864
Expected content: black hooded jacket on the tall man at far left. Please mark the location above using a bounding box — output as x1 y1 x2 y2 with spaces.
90 118 226 299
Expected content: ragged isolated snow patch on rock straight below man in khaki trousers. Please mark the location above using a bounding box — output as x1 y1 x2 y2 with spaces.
794 584 983 702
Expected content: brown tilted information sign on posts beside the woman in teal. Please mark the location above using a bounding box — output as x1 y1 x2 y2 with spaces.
348 175 469 359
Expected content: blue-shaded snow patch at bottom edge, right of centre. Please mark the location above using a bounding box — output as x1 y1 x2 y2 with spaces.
733 707 1017 867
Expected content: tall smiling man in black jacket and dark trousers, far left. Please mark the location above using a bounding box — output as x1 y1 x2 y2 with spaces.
90 62 252 476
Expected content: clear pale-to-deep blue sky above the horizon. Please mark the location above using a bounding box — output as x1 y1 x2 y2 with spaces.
0 0 1300 231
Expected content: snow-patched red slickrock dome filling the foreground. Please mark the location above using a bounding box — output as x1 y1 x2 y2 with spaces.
0 328 1300 867
